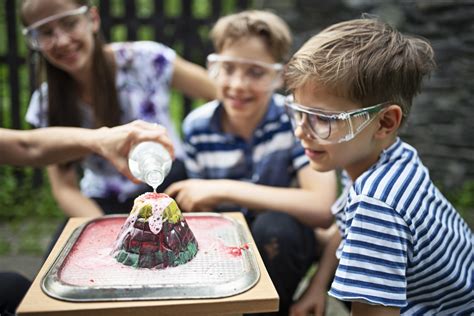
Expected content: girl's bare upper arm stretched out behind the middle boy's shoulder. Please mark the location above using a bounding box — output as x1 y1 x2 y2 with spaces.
171 56 216 100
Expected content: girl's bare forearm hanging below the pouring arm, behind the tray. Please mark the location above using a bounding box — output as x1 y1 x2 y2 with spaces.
48 165 103 217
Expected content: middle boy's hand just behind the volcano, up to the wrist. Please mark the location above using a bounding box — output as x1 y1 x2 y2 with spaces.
165 179 228 212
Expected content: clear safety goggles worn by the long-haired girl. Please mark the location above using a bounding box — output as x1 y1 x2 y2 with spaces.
23 6 89 50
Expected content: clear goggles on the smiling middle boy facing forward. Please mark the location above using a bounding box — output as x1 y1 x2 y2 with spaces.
207 54 283 91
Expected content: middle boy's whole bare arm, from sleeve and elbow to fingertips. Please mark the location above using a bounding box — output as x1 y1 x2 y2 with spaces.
166 166 336 227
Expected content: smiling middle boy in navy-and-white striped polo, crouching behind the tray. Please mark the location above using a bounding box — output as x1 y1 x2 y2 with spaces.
167 11 337 315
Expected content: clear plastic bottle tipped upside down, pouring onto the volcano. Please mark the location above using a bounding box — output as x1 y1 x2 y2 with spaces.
128 141 173 192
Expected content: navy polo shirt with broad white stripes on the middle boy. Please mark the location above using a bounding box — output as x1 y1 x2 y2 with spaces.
183 94 309 187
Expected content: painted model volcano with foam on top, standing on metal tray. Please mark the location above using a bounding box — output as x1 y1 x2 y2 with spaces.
112 193 198 269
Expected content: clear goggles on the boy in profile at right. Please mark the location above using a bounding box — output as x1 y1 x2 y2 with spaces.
285 95 390 144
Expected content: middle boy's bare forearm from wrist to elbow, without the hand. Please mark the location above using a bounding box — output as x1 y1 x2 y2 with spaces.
220 180 333 227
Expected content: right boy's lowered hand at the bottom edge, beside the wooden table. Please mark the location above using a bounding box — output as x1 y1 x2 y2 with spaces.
290 279 326 316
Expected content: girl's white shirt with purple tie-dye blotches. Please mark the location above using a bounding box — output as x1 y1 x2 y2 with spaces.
26 41 182 201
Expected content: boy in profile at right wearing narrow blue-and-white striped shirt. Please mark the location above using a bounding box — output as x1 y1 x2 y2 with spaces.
285 19 474 316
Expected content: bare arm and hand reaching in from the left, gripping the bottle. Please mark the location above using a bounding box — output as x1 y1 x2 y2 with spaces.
0 121 173 179
